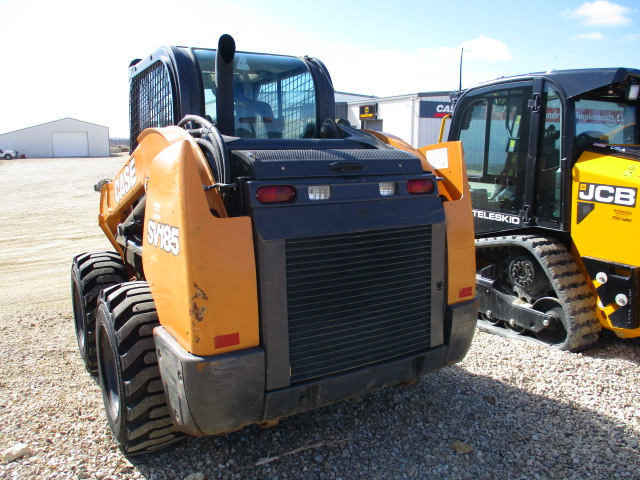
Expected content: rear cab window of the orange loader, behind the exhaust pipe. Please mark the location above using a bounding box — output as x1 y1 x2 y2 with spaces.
194 49 316 138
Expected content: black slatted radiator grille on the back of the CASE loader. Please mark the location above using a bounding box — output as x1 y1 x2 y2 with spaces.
286 226 431 382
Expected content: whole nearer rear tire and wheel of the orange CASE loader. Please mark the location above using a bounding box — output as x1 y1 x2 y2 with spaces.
96 282 183 456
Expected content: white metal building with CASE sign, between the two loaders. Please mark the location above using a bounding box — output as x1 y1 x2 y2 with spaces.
336 92 453 147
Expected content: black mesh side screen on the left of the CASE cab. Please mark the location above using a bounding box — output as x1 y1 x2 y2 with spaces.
129 61 175 150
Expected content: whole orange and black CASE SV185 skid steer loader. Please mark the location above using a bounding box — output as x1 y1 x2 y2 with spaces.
72 36 477 455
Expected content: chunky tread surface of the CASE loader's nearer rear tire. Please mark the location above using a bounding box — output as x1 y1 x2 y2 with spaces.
103 282 184 455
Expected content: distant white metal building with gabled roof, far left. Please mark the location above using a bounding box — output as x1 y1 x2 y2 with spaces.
0 118 109 158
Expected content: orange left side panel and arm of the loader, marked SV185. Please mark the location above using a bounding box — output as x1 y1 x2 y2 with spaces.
99 127 259 356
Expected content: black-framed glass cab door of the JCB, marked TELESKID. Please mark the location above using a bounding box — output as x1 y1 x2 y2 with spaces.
451 81 540 234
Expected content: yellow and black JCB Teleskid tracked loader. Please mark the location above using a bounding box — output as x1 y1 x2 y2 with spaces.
449 68 640 351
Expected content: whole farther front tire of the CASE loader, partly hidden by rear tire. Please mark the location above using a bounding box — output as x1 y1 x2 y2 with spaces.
71 252 127 375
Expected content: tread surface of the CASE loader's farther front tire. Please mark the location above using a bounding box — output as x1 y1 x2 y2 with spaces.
71 252 127 376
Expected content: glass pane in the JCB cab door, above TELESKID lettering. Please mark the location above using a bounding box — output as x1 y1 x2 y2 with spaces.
460 88 531 213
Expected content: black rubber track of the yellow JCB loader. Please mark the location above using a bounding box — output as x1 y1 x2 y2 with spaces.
476 235 602 352
